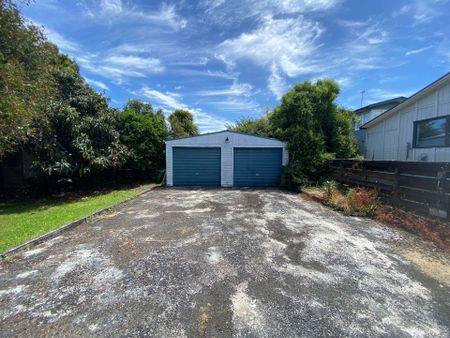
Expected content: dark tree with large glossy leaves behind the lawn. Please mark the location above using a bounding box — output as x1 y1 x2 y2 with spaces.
29 48 128 177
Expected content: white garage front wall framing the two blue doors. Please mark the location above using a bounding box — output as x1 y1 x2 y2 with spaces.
166 131 289 187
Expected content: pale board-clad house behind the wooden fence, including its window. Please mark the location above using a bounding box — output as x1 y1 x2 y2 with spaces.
361 72 450 162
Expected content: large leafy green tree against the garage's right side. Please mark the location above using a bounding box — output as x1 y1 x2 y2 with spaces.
269 80 356 187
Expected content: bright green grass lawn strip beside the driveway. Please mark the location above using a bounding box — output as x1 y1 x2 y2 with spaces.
0 186 149 253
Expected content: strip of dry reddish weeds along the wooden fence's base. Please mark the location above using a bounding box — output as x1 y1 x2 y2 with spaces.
305 181 450 250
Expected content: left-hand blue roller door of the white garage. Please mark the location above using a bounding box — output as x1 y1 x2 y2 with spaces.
173 147 220 186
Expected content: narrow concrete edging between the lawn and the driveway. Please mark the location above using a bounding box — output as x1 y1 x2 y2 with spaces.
0 184 161 259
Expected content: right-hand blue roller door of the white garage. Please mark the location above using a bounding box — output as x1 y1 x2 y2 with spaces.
234 148 283 187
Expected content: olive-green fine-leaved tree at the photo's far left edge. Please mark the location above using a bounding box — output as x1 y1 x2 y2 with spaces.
0 0 54 159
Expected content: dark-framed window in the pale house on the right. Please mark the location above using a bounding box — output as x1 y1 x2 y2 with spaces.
414 116 450 148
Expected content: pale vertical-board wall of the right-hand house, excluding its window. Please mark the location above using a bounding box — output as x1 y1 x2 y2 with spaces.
365 83 450 162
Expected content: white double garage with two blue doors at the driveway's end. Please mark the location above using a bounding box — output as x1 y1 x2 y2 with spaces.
166 131 289 187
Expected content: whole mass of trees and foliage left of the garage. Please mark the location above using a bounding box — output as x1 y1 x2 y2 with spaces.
0 0 198 190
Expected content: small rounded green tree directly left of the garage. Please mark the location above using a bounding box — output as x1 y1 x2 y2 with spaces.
119 99 169 174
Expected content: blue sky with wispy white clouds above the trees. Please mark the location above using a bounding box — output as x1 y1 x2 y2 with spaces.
21 0 450 132
